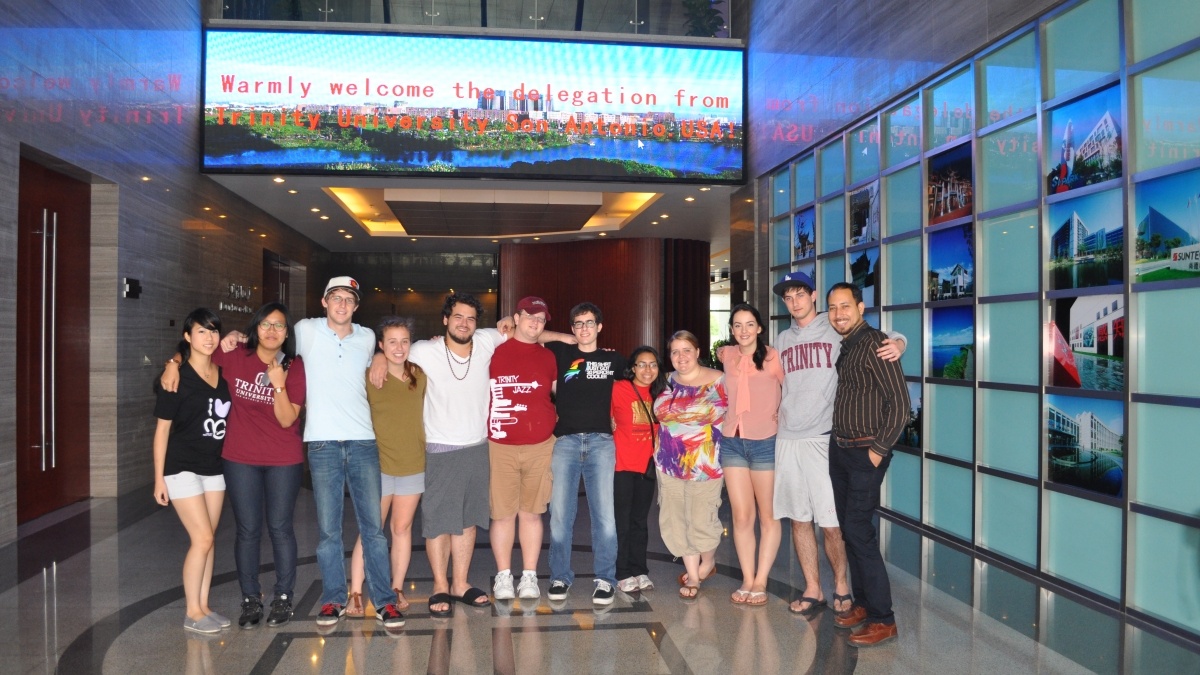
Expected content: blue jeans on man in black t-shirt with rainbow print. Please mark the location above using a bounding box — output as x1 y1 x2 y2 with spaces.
550 434 617 585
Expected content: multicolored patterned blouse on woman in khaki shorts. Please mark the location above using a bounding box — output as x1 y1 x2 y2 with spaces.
654 374 730 480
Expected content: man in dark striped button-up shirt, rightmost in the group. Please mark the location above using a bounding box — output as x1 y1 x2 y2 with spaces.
826 282 908 646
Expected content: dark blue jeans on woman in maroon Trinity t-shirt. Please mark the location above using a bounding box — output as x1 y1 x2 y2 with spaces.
224 460 304 597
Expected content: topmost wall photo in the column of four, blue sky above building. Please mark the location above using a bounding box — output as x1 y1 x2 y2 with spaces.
1044 86 1124 195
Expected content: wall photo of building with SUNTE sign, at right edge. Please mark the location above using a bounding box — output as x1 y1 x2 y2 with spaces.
1133 169 1200 283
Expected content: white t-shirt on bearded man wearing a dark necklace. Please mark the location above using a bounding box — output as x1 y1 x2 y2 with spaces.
408 328 504 446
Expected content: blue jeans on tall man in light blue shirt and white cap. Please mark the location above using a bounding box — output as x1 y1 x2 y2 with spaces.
308 441 396 608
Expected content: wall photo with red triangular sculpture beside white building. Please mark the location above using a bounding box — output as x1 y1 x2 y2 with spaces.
1045 293 1126 392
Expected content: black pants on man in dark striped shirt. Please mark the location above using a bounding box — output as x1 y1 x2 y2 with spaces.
829 436 895 623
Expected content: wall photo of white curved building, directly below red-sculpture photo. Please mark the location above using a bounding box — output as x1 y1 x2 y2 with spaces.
1045 394 1126 497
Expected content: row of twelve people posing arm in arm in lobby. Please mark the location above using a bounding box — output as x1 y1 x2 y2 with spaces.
155 267 908 645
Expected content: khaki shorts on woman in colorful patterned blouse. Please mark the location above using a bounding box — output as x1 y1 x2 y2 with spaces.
659 471 725 556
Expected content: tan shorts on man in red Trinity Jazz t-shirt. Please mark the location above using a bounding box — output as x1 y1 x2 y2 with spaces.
487 436 554 520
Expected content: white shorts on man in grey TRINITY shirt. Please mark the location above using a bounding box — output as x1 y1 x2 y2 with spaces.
774 436 838 527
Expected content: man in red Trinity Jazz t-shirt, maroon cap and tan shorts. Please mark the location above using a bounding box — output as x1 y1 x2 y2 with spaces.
487 297 558 601
